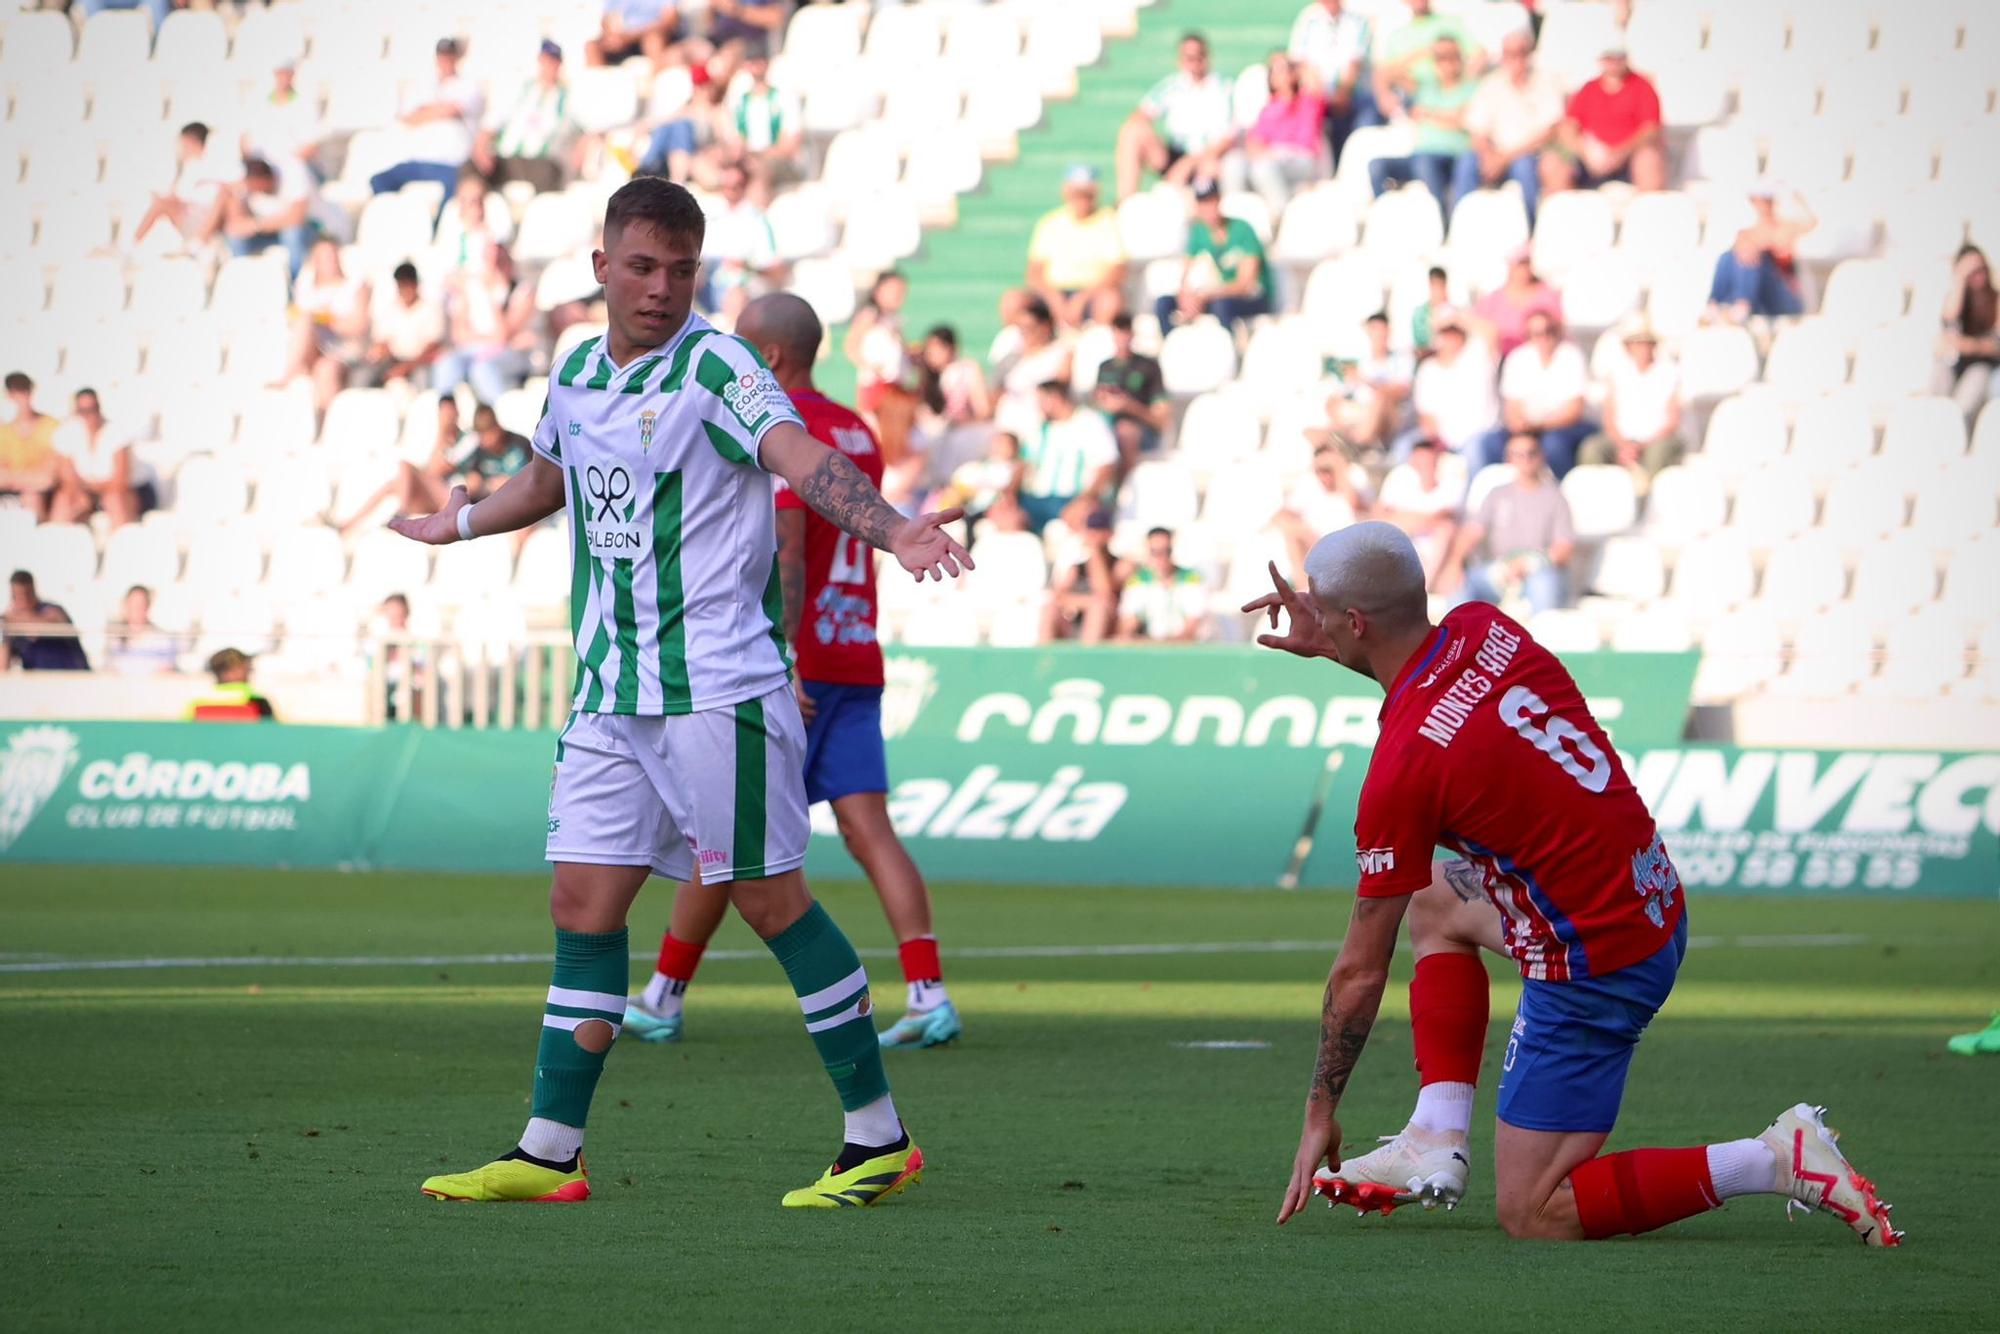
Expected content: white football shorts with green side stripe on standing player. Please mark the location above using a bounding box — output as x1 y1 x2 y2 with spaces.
548 684 810 884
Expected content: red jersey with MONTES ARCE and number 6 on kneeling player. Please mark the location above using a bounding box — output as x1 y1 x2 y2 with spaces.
1354 602 1682 982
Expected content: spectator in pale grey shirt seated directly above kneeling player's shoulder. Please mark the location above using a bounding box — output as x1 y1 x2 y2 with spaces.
1438 434 1576 614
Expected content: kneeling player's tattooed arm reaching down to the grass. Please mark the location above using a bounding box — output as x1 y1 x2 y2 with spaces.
1278 894 1410 1222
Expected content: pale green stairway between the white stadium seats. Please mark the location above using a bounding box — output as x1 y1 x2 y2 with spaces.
884 0 1300 366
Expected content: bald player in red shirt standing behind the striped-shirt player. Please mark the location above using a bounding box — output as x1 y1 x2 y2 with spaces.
624 292 960 1048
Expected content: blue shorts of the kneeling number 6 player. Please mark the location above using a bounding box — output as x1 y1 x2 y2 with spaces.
1498 912 1688 1130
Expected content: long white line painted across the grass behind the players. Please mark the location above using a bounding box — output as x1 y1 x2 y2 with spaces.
0 934 1868 974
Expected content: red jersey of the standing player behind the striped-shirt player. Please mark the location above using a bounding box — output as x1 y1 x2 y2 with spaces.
772 390 882 686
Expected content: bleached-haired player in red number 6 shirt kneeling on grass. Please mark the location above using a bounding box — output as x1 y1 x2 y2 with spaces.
1244 524 1900 1246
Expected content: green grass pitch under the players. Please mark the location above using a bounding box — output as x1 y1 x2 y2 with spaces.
0 868 2000 1334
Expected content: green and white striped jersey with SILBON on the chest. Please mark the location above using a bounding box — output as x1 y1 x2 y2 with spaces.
534 312 798 716
